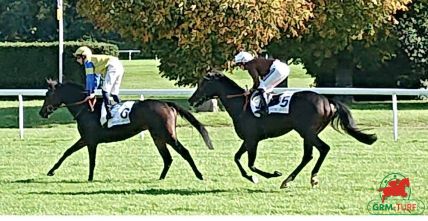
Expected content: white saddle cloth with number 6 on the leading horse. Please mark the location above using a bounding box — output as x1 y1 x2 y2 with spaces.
100 101 134 128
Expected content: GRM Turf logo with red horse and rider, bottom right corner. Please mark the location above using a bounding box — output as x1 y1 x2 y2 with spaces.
367 173 425 215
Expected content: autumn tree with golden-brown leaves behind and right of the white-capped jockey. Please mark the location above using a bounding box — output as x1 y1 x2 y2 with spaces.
268 0 410 87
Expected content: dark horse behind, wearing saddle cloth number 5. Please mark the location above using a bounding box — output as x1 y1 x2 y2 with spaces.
189 73 377 188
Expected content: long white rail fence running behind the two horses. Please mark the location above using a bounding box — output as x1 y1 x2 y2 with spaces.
0 88 428 141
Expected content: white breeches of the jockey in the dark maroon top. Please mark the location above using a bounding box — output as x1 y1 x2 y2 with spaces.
258 60 290 92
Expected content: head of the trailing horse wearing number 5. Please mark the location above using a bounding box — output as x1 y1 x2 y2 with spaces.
188 71 225 106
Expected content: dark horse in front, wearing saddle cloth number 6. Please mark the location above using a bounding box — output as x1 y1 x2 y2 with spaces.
39 81 213 181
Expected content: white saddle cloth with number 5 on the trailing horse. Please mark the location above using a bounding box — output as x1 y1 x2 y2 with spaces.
250 91 294 117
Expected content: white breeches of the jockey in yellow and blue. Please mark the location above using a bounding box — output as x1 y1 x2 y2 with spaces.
102 59 124 95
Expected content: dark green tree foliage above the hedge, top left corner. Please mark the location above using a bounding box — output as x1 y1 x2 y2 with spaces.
0 0 123 42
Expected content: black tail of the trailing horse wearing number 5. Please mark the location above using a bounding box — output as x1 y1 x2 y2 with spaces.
329 99 377 145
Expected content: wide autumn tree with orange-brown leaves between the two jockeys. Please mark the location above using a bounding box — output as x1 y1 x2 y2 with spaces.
78 0 313 85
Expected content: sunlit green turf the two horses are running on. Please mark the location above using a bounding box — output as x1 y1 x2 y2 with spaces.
0 101 428 215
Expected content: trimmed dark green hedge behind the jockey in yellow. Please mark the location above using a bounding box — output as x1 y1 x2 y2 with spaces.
0 42 118 89
